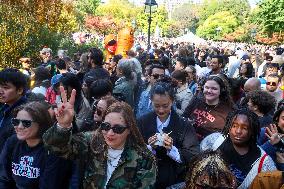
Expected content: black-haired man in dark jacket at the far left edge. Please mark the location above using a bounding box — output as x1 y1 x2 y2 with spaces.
0 68 27 152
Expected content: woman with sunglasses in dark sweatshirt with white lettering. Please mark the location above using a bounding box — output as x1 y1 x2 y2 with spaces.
0 102 71 189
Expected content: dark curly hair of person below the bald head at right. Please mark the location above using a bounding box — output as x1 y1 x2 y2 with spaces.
246 90 276 114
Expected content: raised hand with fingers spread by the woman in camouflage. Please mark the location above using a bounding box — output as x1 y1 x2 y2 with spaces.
54 86 76 128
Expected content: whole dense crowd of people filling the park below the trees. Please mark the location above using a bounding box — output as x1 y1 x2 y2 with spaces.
0 40 284 189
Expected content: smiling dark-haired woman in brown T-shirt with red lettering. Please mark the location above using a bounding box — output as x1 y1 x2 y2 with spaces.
183 75 232 140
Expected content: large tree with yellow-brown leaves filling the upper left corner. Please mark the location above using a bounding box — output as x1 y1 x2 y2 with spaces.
0 0 78 67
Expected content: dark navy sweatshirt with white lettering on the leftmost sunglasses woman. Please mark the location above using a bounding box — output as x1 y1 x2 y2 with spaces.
0 135 71 189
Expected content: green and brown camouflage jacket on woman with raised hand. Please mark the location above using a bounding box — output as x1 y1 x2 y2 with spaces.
43 126 156 189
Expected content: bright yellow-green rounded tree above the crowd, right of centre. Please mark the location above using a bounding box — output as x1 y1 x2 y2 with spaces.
197 11 239 40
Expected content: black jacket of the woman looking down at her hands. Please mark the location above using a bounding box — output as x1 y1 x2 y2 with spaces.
137 111 199 188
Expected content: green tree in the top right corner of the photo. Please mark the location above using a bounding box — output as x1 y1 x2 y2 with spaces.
252 0 284 36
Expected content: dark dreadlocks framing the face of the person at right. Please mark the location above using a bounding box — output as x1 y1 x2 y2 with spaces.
222 108 260 144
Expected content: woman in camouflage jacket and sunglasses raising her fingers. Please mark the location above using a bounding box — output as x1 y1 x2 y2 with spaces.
44 87 156 189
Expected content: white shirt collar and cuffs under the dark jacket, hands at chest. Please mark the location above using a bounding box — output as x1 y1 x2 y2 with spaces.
147 114 181 163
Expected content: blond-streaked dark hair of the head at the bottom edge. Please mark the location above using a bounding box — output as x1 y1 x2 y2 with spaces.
186 151 237 189
